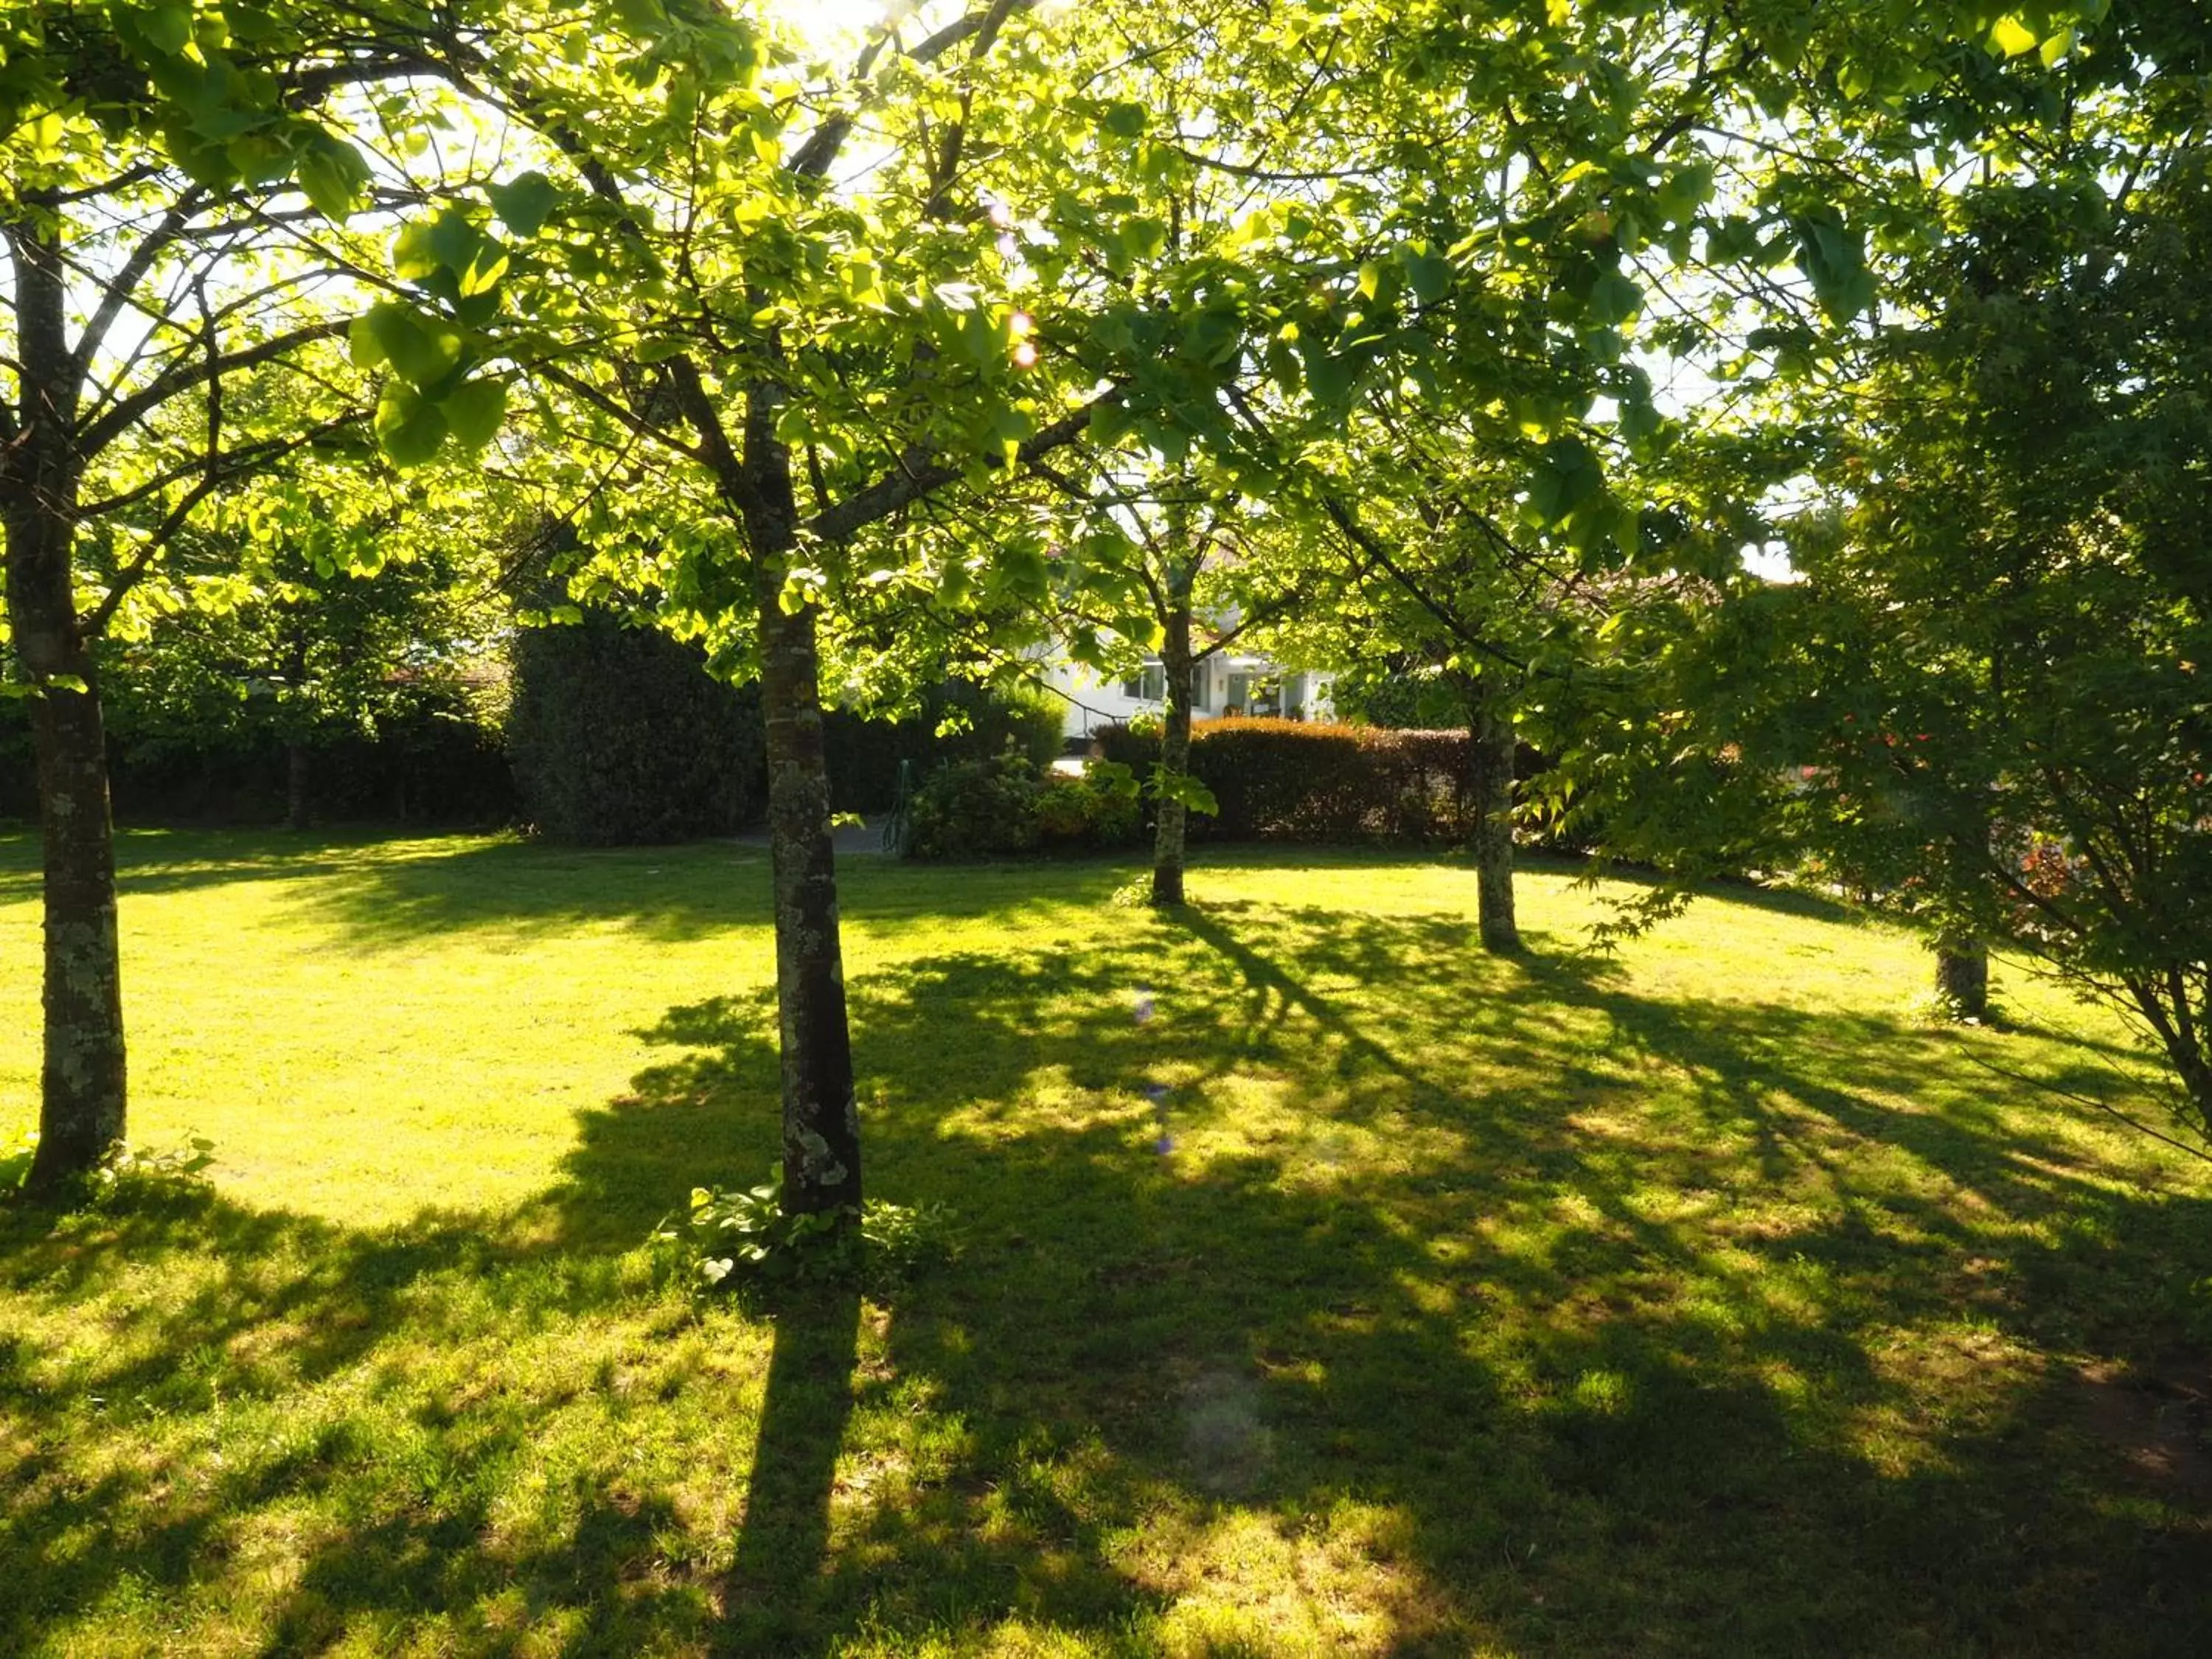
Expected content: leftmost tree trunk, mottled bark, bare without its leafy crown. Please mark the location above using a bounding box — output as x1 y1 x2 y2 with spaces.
0 211 126 1192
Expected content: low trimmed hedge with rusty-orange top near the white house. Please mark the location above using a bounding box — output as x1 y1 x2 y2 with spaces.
1097 719 1469 841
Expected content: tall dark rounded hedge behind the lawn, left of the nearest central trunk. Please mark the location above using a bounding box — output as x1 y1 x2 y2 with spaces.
507 611 768 847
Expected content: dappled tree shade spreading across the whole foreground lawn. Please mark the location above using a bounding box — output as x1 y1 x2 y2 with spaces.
0 889 2212 1655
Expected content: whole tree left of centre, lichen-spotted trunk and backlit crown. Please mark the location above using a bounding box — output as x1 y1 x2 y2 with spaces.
365 0 1124 1212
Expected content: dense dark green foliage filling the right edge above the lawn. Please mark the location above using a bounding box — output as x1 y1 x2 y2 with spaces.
1601 4 2212 1135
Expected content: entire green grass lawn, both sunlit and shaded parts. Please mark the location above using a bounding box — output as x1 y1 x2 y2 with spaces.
0 834 2212 1659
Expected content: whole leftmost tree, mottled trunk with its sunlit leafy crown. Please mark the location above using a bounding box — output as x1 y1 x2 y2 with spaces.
0 2 458 1188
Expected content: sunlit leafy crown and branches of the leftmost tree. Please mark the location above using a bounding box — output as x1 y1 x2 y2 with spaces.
0 4 504 633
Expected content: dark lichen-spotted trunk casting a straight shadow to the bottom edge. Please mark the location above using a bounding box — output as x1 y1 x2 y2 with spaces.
743 385 860 1214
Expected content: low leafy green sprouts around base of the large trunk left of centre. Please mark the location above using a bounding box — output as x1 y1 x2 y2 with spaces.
653 1164 960 1290
